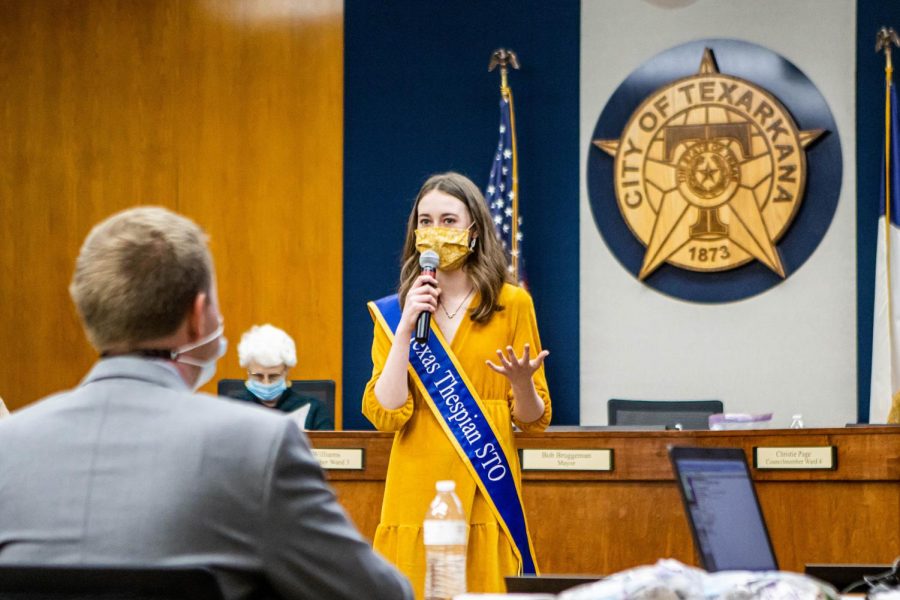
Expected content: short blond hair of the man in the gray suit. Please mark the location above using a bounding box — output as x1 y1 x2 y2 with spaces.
69 206 212 352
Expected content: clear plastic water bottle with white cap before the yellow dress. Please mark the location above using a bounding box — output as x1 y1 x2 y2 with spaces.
424 481 468 600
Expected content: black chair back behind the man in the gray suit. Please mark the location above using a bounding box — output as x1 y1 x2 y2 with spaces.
0 565 223 600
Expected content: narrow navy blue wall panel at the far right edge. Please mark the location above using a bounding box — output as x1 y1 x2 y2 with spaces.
856 0 900 422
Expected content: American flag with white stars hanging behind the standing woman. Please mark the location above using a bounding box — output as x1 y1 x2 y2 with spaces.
484 88 525 281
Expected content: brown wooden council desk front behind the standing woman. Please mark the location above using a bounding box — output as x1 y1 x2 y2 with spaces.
309 427 900 574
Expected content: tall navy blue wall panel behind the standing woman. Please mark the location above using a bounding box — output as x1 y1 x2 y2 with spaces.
343 0 580 429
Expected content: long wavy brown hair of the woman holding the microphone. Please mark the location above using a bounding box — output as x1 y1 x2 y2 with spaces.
399 172 512 323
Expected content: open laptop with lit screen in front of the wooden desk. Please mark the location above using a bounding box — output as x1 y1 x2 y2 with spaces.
669 447 778 573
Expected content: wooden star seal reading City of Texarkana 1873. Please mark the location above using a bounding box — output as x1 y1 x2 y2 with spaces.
593 48 825 280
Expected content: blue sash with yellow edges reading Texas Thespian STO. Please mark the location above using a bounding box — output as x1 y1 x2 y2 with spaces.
368 294 537 575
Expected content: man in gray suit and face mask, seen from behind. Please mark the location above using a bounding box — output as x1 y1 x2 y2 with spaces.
0 207 412 599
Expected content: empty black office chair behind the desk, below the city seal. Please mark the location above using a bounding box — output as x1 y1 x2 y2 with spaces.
606 398 724 429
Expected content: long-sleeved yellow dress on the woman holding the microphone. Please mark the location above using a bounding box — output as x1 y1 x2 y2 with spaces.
362 284 550 598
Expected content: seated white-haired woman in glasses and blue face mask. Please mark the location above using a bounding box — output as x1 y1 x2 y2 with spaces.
235 324 334 430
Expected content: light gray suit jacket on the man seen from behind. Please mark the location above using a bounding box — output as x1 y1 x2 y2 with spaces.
0 357 414 600
